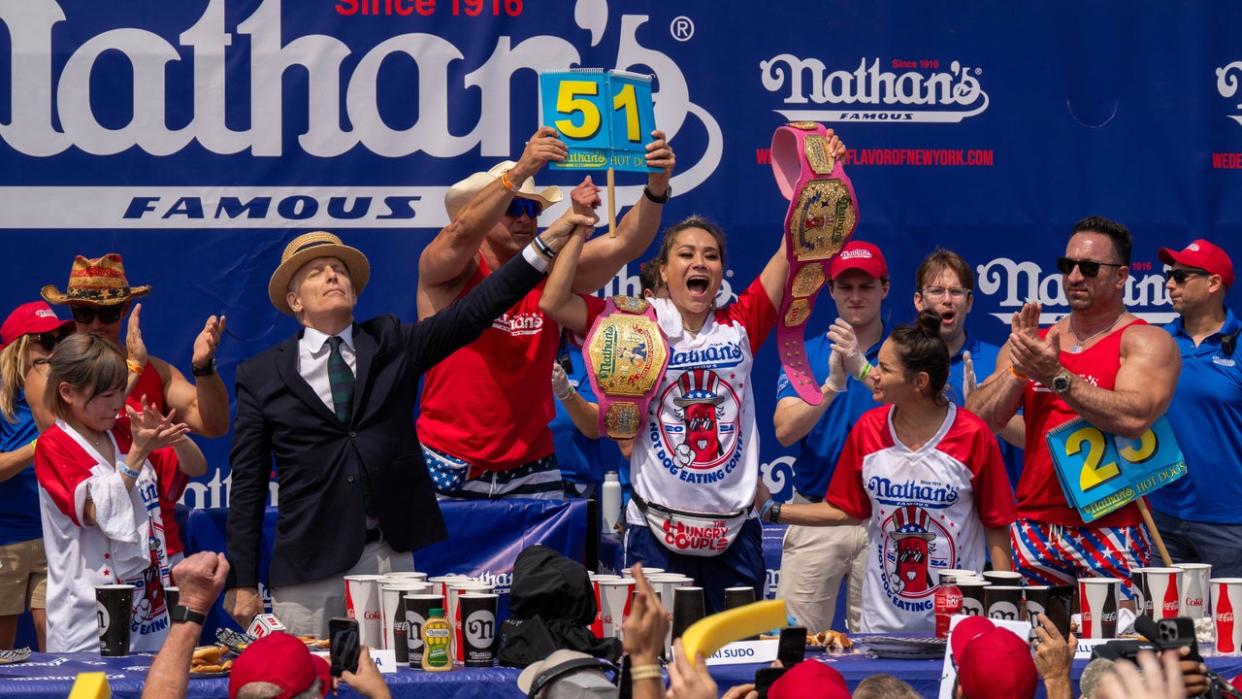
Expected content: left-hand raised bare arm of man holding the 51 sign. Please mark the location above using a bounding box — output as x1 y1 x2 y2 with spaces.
419 127 569 293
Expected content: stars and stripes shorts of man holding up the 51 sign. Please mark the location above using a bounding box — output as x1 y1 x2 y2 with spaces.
422 444 565 500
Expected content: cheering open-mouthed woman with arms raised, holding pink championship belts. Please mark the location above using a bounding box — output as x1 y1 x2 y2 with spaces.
539 132 845 613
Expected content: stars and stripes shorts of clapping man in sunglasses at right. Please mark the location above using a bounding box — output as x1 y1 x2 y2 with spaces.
1010 519 1151 598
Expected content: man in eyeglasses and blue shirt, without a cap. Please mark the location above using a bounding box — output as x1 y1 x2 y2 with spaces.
914 248 1026 484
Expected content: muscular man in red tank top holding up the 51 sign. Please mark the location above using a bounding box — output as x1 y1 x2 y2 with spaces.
419 127 674 498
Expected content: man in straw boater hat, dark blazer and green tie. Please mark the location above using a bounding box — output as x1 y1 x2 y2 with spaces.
225 212 595 637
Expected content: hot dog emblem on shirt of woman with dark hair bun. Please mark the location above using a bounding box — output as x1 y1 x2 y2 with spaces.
879 505 958 608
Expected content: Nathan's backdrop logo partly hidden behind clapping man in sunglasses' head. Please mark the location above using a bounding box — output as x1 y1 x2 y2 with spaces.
975 257 1177 325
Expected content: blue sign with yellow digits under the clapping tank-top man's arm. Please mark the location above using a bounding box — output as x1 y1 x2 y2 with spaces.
1047 417 1186 521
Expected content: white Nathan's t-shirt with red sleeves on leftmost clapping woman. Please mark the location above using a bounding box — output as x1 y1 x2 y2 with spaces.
35 417 171 653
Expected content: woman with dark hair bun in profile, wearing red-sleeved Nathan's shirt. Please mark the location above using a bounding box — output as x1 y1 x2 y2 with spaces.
759 310 1015 633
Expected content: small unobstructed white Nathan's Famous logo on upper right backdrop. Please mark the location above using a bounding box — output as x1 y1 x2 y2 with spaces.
759 53 987 124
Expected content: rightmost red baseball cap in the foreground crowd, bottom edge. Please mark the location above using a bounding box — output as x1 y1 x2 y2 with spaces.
949 616 1040 699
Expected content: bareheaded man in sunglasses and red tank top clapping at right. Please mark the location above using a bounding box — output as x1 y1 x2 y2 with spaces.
966 216 1181 597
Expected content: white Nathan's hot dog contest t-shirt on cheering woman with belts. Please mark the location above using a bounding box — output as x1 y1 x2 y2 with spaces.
587 279 776 555
